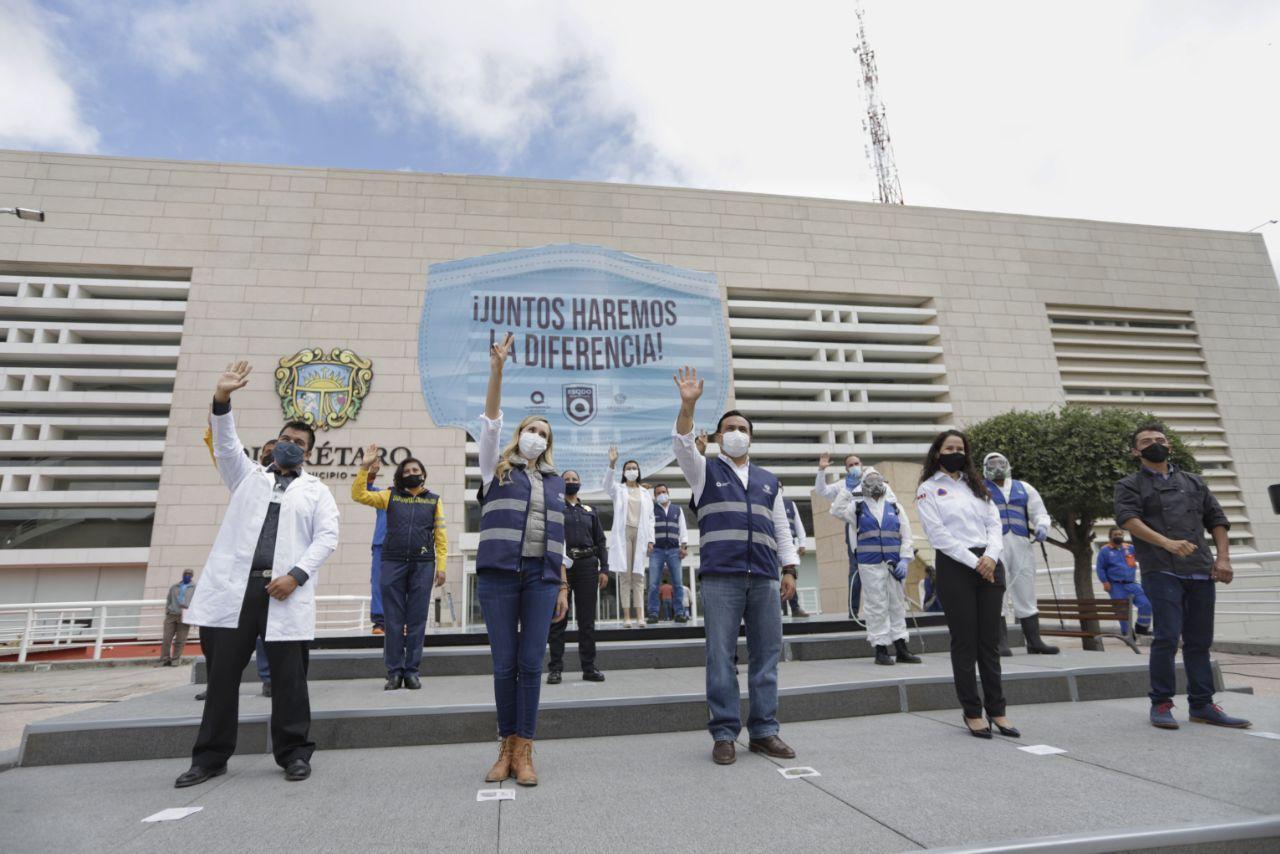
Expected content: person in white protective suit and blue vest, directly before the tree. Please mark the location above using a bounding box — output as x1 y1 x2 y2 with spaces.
982 453 1059 656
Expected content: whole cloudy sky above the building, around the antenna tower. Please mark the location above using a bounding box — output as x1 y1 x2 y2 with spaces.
0 0 1280 267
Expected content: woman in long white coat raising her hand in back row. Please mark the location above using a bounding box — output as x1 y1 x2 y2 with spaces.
603 446 653 629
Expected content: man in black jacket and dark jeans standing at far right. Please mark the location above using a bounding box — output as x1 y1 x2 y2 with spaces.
1115 424 1249 730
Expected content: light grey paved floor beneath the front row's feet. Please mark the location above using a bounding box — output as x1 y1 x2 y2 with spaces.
0 696 1280 854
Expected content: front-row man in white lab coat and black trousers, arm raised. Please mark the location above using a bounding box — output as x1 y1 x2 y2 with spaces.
174 361 338 789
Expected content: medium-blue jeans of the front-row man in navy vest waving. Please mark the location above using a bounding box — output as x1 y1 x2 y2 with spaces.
699 572 782 741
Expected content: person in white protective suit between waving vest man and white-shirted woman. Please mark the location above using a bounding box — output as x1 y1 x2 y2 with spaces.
831 467 920 665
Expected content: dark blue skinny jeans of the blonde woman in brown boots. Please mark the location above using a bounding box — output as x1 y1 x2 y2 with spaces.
476 557 559 739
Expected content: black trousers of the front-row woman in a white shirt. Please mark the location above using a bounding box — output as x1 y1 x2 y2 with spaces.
937 549 1005 718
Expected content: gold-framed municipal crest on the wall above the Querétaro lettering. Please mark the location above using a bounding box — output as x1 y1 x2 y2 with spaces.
275 347 374 430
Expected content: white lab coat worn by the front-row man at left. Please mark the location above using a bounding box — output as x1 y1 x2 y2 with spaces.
183 412 338 640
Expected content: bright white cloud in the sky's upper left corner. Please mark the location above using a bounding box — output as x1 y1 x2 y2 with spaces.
0 0 99 152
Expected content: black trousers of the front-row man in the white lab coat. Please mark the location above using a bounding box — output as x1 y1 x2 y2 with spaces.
191 576 316 768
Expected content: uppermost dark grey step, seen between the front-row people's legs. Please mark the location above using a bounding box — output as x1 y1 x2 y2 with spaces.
191 626 1023 684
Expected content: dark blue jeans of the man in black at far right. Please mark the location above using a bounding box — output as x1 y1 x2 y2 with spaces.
1142 572 1216 708
